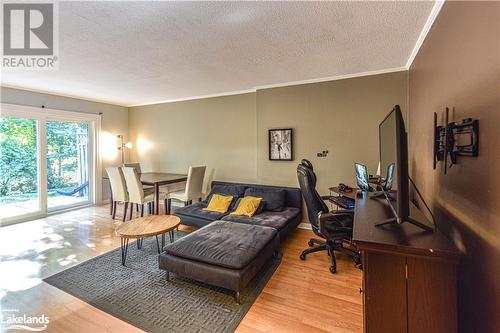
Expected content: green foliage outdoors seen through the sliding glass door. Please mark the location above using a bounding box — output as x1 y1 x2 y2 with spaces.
0 118 88 201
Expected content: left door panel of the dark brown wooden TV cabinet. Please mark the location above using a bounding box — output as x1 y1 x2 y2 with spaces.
363 252 407 333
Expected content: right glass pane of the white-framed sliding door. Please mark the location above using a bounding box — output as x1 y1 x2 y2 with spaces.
46 121 90 211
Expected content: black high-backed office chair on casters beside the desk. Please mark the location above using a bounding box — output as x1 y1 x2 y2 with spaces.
297 160 361 273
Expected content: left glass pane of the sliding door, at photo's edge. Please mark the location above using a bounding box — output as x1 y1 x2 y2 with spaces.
0 117 41 219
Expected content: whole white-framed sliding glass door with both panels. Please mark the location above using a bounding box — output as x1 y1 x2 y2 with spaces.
0 104 100 225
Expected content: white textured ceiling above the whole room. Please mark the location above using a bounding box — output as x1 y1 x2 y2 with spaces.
2 1 434 105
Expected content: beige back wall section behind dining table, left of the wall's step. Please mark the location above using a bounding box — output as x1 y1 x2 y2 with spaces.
129 93 257 182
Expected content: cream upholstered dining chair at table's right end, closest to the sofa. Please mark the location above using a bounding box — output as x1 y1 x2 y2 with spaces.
164 165 206 214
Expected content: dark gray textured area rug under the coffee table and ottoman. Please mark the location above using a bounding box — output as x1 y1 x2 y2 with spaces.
44 232 281 332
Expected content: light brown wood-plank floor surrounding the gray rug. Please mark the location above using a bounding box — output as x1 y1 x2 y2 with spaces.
0 206 363 333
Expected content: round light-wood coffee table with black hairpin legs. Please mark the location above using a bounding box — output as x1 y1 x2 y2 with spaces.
116 215 181 266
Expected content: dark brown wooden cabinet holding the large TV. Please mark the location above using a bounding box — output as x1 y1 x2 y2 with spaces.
353 193 460 333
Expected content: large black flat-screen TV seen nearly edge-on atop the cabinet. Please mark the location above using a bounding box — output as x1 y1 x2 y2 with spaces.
377 105 432 231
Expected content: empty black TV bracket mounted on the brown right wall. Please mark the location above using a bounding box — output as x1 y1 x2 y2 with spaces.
433 108 479 174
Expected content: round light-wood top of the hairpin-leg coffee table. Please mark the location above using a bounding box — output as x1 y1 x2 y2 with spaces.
116 215 181 238
